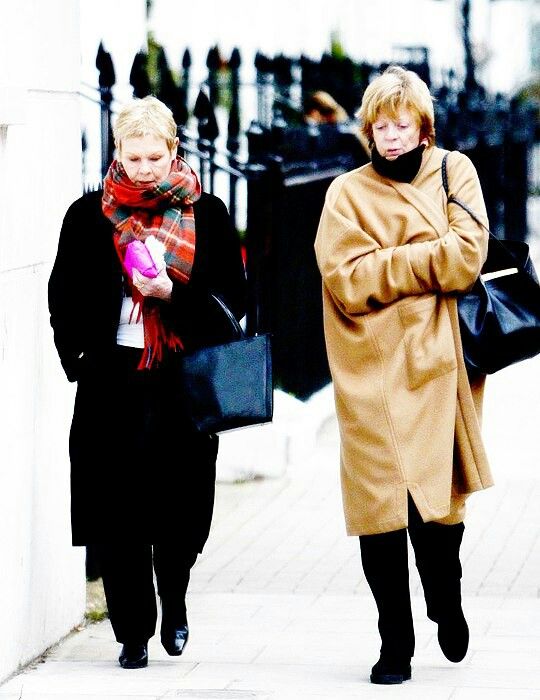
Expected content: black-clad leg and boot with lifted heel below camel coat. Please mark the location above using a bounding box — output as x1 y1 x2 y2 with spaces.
409 499 469 663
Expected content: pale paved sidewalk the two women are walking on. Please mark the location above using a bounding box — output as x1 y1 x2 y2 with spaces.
0 206 540 700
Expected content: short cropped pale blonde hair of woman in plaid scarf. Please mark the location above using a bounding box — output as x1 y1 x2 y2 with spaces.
113 95 176 151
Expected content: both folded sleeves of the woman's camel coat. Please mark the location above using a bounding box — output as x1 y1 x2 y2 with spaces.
315 154 487 314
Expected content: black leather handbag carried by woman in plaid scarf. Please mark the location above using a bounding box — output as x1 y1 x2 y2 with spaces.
179 294 274 433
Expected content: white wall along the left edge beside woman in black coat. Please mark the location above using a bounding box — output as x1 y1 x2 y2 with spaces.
0 0 85 681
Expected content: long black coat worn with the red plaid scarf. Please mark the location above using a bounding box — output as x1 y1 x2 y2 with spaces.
49 191 246 551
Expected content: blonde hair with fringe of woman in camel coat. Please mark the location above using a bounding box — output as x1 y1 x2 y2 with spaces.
356 66 435 146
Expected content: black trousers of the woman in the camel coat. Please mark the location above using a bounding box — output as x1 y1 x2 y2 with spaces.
360 495 464 664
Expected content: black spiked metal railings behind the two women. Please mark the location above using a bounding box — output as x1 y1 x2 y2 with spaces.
83 46 538 398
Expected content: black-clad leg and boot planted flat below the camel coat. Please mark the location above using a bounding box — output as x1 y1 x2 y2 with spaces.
360 530 415 685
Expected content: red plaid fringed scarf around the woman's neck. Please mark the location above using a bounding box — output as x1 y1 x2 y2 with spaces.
102 156 201 369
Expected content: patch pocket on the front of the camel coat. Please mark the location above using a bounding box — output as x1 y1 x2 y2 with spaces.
399 294 457 389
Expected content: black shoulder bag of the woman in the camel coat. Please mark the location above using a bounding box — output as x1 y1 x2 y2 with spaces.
442 155 540 374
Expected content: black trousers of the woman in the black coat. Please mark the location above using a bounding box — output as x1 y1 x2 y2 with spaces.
98 543 198 644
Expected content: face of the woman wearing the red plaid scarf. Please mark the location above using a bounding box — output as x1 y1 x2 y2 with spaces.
119 134 178 187
